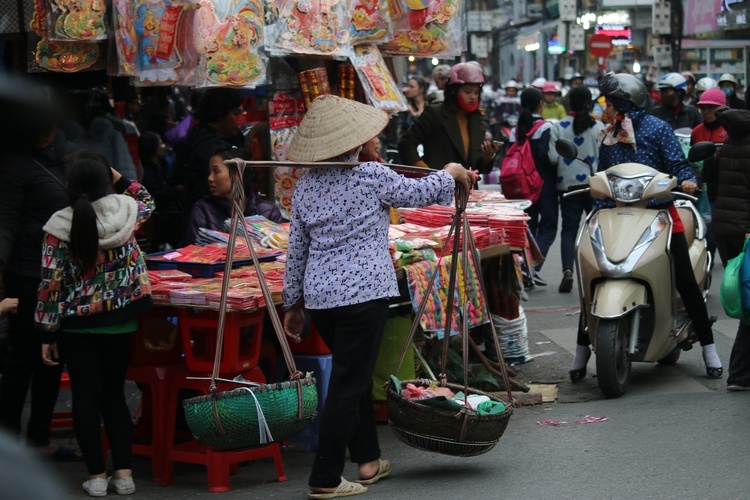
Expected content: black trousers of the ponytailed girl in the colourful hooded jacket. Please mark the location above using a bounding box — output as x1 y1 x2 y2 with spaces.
58 332 133 476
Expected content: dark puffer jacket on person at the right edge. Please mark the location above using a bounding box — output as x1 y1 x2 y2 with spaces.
713 106 750 242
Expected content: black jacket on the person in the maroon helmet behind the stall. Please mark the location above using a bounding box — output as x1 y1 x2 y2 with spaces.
398 101 492 173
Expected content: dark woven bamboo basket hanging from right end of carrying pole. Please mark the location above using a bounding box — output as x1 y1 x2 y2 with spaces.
387 379 513 457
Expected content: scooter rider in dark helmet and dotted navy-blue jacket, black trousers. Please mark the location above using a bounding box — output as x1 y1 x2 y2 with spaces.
570 73 723 382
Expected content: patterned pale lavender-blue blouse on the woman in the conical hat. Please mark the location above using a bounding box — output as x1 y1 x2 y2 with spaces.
284 162 455 310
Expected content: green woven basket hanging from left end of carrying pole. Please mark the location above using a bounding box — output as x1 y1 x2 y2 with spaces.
187 377 318 450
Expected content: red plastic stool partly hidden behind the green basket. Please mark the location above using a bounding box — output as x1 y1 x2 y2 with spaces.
164 366 286 493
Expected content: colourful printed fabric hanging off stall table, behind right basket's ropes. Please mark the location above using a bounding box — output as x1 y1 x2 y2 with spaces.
404 252 489 338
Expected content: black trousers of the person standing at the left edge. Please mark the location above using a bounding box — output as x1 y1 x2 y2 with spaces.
0 276 62 447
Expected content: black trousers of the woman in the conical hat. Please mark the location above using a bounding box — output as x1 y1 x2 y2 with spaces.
309 299 388 488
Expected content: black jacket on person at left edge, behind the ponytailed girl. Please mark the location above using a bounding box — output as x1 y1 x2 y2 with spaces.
0 132 76 279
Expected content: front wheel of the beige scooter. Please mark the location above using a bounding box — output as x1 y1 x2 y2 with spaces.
596 314 632 398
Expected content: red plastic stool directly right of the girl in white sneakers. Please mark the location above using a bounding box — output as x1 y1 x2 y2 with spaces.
127 364 181 486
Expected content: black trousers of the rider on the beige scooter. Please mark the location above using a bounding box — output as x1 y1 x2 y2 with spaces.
576 233 714 346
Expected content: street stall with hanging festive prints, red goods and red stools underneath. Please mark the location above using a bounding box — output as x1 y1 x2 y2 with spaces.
20 0 540 491
